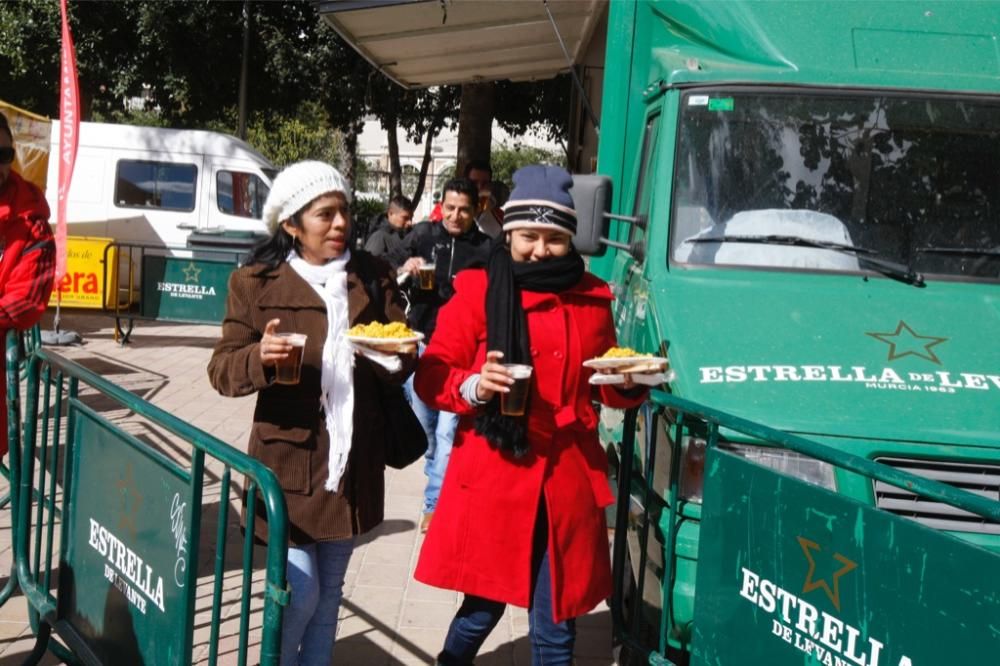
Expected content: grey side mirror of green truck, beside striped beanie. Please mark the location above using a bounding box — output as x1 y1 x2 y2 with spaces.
569 174 646 262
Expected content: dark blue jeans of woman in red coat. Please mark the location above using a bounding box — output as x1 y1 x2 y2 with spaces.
437 506 576 666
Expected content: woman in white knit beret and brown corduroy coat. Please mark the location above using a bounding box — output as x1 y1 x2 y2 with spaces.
208 162 415 665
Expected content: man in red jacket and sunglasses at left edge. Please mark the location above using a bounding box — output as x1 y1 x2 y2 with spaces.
0 113 56 456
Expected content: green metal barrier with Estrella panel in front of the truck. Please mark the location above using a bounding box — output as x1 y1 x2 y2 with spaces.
612 391 1000 666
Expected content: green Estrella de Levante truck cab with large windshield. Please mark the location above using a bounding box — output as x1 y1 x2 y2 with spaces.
577 0 1000 650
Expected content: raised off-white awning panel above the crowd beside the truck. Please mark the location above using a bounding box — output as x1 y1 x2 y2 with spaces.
316 0 607 88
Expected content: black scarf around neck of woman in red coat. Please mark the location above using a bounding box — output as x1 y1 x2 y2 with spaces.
476 236 584 458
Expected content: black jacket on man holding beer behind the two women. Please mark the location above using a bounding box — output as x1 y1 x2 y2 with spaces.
403 222 490 342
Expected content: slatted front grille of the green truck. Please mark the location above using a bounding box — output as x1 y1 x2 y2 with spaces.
875 458 1000 534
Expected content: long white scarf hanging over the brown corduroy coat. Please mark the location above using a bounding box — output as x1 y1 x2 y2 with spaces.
287 250 354 492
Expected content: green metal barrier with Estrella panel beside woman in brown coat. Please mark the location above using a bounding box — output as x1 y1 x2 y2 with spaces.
0 334 288 666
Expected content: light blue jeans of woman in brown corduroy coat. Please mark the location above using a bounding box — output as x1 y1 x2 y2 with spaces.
281 539 354 666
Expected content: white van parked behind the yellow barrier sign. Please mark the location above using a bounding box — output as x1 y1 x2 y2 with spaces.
46 121 276 247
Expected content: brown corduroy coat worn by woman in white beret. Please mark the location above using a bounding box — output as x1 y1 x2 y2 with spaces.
208 251 416 545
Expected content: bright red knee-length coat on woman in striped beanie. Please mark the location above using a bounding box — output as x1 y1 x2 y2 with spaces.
414 269 645 622
